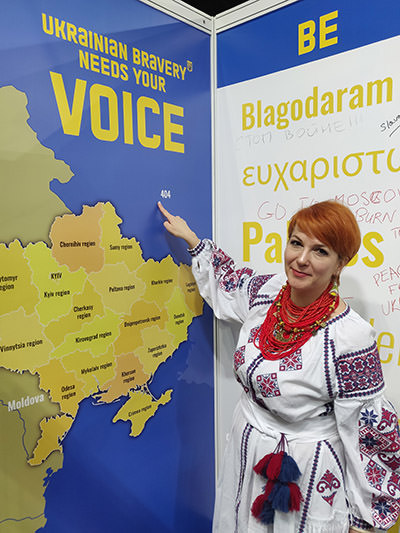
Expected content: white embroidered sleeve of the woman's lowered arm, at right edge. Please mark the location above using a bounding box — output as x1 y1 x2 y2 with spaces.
334 328 400 529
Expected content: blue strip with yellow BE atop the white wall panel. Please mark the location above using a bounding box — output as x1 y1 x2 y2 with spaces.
217 0 400 87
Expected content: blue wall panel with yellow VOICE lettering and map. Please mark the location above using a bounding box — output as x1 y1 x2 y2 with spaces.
0 0 214 533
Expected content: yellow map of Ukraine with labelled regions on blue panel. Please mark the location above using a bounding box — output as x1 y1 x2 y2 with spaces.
0 203 202 454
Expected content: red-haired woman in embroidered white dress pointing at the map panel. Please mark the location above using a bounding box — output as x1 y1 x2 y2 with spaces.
159 197 400 533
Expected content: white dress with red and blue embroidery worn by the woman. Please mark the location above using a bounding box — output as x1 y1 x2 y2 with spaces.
192 239 400 533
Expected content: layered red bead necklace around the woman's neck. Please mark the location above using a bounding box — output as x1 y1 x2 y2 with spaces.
254 282 339 361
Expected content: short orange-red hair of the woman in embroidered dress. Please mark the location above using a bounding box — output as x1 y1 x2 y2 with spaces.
288 200 361 263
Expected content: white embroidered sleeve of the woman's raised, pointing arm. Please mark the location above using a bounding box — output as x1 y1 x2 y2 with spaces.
192 239 271 323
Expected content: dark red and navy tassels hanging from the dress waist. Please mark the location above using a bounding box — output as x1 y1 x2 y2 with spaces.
251 433 303 524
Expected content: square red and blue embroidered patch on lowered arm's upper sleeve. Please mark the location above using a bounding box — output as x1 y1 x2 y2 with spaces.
335 343 384 398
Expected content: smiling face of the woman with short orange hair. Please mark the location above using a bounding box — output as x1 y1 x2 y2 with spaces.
285 226 343 307
